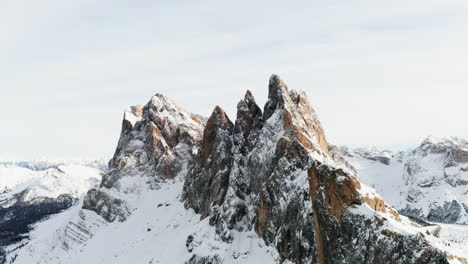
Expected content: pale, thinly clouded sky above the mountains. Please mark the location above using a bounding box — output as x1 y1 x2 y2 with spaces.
0 0 468 159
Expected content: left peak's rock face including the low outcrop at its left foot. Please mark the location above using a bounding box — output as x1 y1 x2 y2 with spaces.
83 94 208 222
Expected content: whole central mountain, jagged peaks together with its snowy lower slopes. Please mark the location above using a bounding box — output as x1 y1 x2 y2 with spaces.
1 75 468 264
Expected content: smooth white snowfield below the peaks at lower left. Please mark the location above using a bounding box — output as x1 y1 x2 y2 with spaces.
11 179 278 264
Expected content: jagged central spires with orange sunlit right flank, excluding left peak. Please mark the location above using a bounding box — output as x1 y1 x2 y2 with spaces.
182 75 447 263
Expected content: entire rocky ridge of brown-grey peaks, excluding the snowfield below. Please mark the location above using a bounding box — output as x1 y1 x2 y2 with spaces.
83 75 448 264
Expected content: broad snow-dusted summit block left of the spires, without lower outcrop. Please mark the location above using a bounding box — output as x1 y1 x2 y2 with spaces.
109 94 203 183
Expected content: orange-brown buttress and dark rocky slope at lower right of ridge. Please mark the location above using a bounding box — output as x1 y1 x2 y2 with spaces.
309 163 448 264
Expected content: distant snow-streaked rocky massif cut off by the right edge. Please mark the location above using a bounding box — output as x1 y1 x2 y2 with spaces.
401 137 468 224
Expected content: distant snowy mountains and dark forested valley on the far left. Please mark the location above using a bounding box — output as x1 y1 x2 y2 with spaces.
0 160 102 263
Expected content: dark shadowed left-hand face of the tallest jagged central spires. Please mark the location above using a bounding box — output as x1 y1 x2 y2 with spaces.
183 77 320 263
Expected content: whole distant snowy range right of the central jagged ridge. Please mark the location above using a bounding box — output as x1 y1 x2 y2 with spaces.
333 137 468 224
